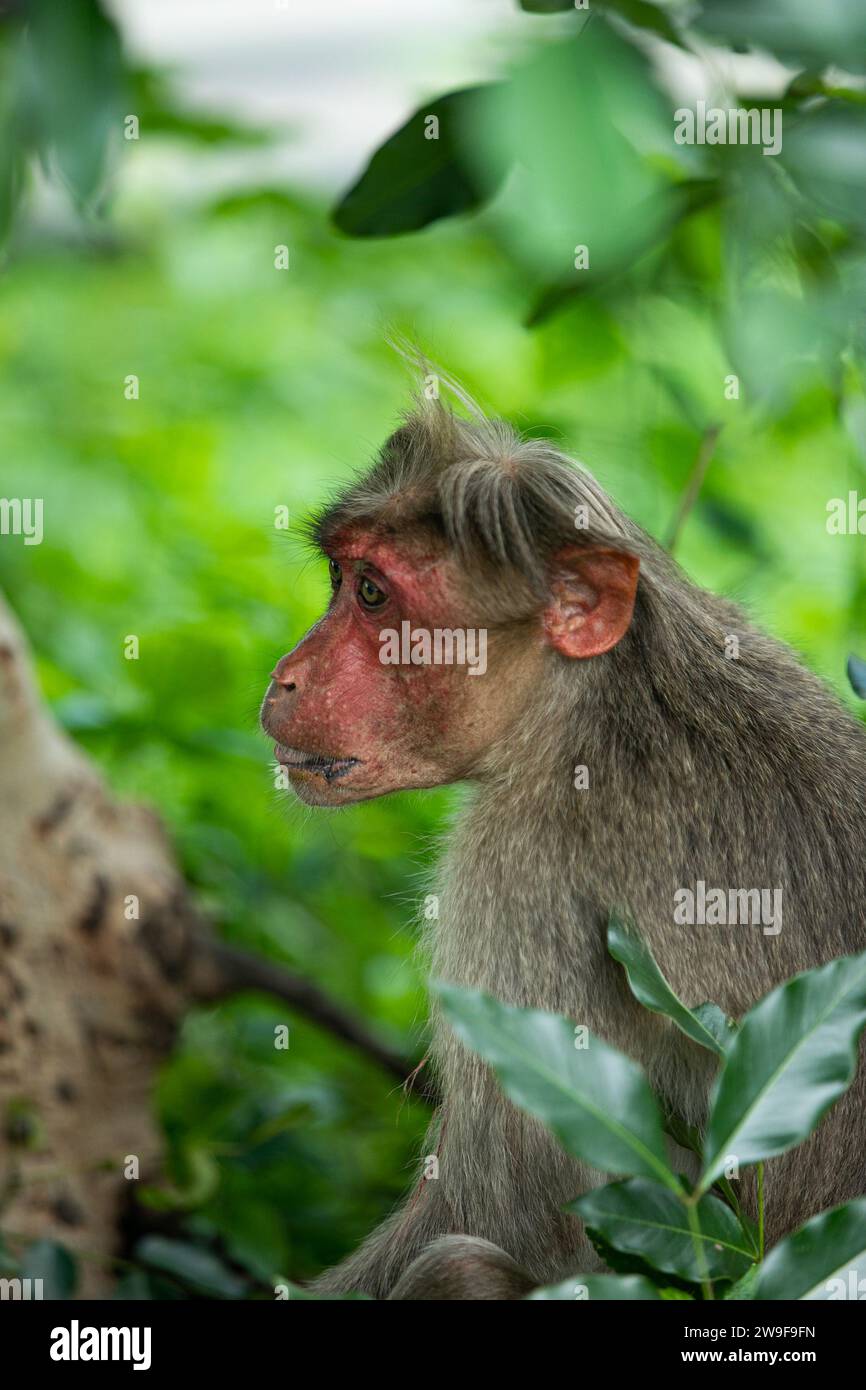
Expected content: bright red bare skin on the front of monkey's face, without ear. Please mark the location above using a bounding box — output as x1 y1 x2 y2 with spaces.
261 530 505 806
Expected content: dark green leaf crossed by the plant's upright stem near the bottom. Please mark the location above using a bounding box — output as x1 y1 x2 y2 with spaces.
566 1177 753 1283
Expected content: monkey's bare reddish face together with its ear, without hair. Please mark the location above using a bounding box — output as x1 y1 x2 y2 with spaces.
261 524 638 806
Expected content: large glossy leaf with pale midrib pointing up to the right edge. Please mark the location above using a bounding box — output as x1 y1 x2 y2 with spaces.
701 952 866 1190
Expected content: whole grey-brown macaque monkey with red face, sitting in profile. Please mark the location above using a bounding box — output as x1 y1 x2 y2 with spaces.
263 375 866 1300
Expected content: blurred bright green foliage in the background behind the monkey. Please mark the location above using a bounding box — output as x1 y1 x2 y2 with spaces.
0 0 866 1297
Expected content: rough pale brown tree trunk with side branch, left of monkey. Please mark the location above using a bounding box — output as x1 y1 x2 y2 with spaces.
0 598 422 1295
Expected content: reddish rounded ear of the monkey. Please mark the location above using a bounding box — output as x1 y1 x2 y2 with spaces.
544 546 639 657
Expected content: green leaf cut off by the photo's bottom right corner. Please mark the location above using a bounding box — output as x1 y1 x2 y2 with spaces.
753 1197 866 1300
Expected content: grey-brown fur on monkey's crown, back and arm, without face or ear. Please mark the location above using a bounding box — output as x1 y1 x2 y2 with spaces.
308 406 866 1297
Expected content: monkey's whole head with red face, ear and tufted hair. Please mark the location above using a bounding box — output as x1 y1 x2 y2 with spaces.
261 413 638 806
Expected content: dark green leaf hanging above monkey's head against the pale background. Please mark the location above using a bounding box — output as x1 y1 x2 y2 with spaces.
334 82 507 236
